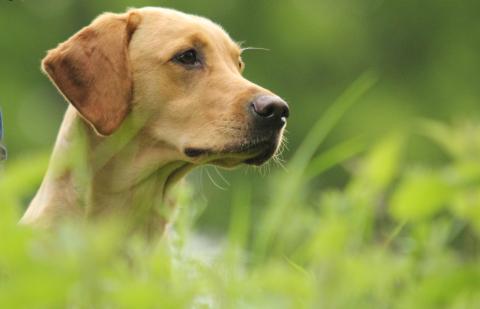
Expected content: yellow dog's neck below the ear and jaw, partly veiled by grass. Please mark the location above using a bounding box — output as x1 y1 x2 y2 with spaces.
22 107 193 230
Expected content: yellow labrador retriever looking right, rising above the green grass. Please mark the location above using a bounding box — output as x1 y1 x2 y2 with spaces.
21 7 289 232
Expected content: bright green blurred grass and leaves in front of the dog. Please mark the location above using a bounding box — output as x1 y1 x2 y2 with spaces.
0 73 480 308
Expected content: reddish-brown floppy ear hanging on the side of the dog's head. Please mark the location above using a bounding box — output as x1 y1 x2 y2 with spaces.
42 12 141 135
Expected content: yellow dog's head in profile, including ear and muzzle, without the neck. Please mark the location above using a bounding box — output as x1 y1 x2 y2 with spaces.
42 8 289 166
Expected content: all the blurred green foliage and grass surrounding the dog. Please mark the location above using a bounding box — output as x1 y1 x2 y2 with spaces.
0 0 480 308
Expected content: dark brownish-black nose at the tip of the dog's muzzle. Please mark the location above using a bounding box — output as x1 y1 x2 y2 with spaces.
251 95 290 126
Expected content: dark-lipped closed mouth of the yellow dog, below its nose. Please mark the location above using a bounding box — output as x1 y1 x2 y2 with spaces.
184 132 279 166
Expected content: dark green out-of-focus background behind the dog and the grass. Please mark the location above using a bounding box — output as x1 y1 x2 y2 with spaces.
0 0 480 233
